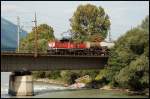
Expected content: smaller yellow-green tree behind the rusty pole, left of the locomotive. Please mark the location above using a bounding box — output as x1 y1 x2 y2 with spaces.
20 24 54 52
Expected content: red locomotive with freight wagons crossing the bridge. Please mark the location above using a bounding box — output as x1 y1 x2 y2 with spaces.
47 39 109 56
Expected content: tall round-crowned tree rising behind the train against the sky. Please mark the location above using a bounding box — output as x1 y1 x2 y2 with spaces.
70 4 110 42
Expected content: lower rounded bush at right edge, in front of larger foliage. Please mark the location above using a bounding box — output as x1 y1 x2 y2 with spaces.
116 55 149 90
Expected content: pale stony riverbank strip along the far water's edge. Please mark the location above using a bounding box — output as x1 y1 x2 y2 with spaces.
34 78 149 96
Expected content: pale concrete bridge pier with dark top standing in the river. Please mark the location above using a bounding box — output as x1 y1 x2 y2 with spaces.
8 71 33 96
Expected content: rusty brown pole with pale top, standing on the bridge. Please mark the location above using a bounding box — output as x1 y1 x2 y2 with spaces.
32 12 38 57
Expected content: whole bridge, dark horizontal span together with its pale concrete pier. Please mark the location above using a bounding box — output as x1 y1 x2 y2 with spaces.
1 52 108 96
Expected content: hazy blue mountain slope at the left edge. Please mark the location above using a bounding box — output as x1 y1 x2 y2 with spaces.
1 18 27 51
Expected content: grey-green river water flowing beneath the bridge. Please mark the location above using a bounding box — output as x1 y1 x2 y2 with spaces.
1 72 148 98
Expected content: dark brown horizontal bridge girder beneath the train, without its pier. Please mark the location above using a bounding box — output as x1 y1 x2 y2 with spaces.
1 53 108 72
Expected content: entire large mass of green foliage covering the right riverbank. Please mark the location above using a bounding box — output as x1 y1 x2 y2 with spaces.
95 17 149 90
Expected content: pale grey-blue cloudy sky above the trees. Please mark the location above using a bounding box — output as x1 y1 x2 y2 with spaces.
1 1 149 40
